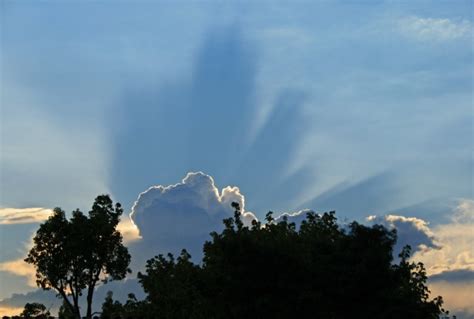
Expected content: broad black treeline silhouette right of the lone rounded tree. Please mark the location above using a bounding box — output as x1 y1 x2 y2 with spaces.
15 196 452 319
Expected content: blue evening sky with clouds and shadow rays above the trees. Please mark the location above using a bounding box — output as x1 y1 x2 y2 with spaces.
0 0 474 318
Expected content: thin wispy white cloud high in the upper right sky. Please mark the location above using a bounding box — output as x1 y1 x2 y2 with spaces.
398 16 473 41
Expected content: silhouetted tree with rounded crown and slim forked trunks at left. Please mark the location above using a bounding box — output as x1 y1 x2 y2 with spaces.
25 195 130 318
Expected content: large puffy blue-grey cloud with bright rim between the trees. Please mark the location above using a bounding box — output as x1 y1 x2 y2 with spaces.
130 172 256 260
